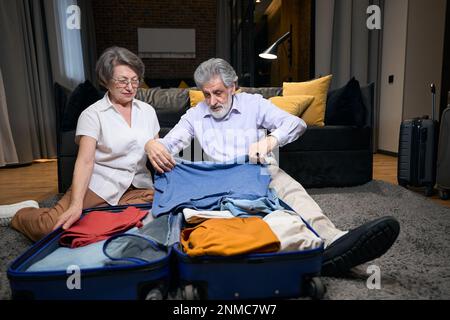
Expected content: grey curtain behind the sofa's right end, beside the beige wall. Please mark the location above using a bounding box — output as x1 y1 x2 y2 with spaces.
315 0 385 151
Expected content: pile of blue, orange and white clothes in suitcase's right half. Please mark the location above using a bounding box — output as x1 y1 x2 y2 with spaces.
152 158 323 257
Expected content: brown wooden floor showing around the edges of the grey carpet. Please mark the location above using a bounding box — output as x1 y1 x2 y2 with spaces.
0 154 450 207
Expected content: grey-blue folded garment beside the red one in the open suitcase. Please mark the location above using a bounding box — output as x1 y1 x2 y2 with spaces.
103 215 181 265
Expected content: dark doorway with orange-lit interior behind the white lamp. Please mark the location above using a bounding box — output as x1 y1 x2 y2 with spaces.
231 0 314 87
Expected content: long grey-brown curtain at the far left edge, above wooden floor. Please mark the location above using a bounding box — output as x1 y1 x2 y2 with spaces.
0 0 56 164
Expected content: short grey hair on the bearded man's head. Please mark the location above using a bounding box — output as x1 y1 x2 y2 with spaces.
194 58 238 88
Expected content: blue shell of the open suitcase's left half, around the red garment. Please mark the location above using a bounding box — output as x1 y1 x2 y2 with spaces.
7 205 179 300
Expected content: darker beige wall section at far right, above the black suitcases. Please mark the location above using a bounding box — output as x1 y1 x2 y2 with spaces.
403 0 446 119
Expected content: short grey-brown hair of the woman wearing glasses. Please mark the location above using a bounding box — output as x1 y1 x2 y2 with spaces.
95 47 145 88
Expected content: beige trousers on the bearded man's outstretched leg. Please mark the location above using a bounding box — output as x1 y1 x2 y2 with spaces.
268 160 345 247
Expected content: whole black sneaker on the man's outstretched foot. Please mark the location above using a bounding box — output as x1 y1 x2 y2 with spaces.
321 217 400 276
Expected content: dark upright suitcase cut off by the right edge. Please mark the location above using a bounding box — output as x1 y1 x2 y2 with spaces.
436 92 450 200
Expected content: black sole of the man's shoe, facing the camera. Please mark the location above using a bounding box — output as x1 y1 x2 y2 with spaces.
321 220 400 276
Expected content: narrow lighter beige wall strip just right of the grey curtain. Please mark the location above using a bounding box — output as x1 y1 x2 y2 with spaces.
378 0 408 152
